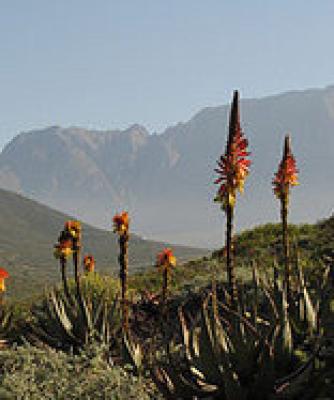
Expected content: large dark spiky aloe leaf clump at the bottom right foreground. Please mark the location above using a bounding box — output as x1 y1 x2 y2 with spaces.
152 294 318 400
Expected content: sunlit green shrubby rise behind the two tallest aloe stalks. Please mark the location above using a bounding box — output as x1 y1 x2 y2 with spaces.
130 216 334 293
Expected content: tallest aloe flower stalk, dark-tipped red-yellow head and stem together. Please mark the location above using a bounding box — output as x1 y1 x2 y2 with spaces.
215 91 251 308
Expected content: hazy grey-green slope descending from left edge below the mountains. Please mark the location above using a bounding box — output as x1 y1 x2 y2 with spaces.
0 189 206 297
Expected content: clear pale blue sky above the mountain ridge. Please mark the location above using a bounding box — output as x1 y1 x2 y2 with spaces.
0 0 334 147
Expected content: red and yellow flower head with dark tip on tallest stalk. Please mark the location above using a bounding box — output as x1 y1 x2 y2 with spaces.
214 91 251 210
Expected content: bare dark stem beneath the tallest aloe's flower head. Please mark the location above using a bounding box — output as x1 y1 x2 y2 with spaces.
226 205 237 309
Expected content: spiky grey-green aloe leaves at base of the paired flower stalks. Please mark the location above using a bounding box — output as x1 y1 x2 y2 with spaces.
27 289 120 351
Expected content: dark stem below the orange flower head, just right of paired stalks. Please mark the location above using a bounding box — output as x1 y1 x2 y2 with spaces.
119 231 129 332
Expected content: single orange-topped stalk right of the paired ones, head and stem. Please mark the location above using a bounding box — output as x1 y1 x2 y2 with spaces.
113 211 130 332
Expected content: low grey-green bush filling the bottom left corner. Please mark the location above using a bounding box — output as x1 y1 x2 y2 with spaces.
0 346 161 400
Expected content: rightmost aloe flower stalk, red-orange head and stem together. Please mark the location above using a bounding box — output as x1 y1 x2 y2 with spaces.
272 135 298 305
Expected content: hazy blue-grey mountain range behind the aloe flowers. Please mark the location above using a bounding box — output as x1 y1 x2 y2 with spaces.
0 86 334 247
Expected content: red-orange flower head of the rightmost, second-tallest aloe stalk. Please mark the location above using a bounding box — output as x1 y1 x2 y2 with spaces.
272 135 298 199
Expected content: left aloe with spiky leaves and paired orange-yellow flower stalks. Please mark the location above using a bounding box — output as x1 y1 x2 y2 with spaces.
28 221 119 351
